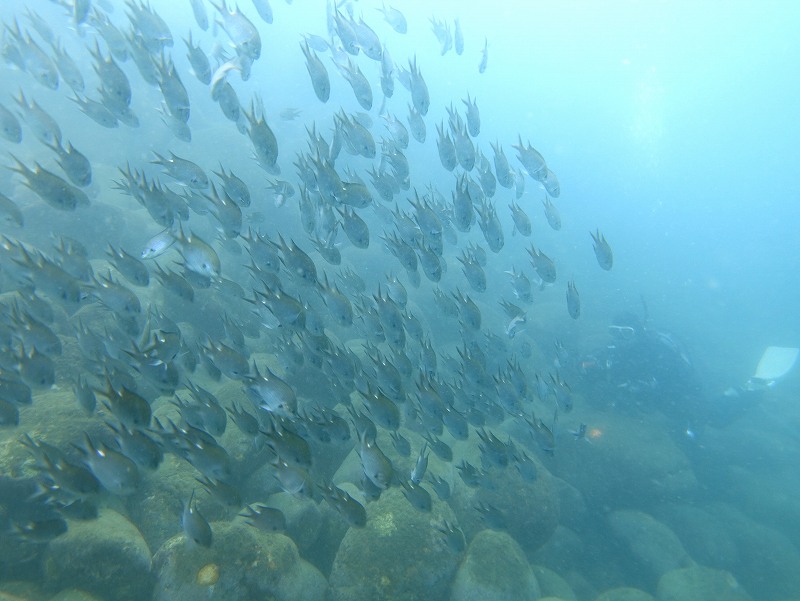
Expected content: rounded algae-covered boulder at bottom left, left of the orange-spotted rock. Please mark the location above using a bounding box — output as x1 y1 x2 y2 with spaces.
44 509 153 601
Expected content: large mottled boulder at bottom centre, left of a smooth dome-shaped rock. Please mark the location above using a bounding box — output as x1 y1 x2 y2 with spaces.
329 487 458 601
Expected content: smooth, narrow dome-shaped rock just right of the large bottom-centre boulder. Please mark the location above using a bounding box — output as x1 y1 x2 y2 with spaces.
450 530 540 601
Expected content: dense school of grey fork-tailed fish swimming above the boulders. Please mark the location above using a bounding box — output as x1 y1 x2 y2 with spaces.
0 0 613 584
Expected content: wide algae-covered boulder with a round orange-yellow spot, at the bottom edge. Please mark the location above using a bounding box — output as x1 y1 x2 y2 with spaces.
153 521 326 601
